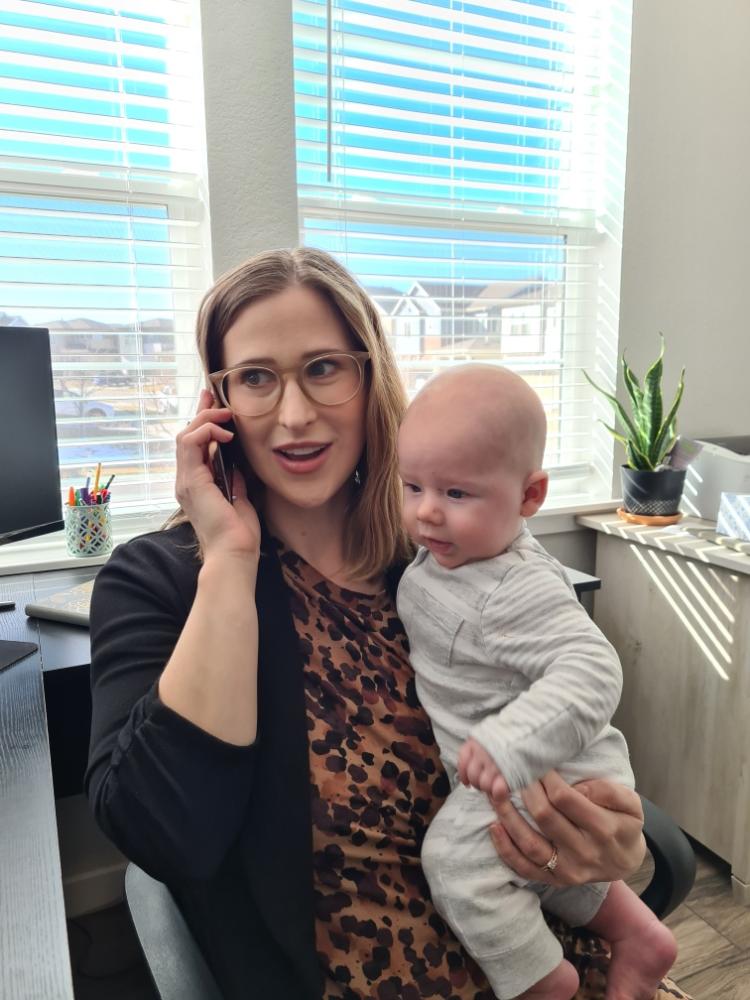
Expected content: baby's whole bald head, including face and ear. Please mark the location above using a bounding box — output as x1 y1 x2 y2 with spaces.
398 364 548 569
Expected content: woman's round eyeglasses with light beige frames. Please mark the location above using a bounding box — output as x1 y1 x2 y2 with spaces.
208 351 370 417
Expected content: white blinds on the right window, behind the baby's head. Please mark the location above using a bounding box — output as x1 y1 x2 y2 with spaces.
294 0 631 504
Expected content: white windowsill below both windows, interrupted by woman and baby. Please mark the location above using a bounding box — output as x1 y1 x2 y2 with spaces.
0 500 619 577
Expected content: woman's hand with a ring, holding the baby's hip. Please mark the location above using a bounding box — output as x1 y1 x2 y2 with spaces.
490 771 646 885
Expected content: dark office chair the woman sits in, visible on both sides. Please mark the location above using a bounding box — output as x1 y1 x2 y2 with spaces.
125 796 695 1000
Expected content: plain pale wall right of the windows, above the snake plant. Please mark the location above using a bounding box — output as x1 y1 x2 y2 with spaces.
616 0 750 450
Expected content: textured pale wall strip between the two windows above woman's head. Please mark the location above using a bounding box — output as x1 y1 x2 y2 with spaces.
201 0 299 277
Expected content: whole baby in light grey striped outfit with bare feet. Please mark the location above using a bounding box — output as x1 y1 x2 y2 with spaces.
398 365 676 1000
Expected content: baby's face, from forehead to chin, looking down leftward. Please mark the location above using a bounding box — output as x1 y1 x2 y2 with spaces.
398 420 524 569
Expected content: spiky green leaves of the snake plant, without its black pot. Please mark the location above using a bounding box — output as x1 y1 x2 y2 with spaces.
583 334 685 471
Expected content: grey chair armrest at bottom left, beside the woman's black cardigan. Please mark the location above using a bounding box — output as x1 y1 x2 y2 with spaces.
125 862 222 1000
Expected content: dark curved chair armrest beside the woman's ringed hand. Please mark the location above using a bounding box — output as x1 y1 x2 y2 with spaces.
641 795 695 920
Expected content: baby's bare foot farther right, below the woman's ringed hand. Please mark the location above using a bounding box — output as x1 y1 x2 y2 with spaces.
605 917 677 1000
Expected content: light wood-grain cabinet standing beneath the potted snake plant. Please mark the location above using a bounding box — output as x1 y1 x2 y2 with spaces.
578 514 750 906
